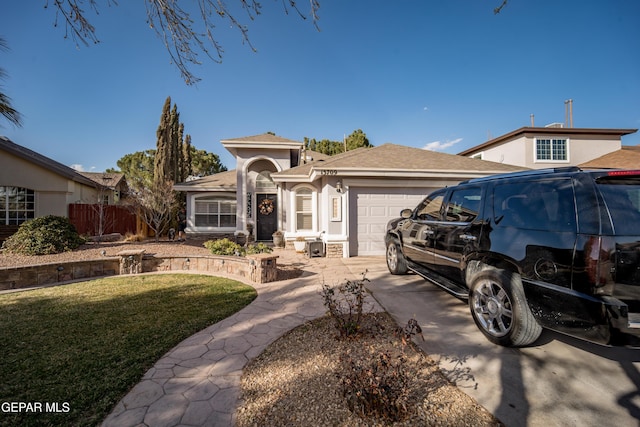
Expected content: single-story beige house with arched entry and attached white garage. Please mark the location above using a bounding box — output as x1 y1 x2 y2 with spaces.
175 134 523 257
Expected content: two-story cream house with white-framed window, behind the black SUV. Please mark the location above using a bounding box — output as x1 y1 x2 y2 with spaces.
458 124 637 169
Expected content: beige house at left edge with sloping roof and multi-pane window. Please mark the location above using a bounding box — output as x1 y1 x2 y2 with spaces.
0 136 99 239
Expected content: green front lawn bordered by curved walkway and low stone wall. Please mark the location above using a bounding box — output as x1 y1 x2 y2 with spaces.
0 274 256 426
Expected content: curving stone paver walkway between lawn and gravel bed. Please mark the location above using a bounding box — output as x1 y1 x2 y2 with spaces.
102 250 379 427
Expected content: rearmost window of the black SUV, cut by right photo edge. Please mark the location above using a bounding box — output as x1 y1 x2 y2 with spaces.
597 178 640 235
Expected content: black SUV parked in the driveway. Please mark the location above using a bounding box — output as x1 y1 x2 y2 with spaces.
385 167 640 347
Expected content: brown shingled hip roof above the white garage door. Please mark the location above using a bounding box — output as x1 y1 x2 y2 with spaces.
271 144 525 182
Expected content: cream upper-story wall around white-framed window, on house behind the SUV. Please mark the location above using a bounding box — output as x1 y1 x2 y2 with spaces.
482 134 622 169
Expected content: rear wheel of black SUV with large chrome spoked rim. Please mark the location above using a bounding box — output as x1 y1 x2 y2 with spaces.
469 267 542 347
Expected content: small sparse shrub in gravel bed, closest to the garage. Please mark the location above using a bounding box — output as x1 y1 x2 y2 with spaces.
320 272 369 337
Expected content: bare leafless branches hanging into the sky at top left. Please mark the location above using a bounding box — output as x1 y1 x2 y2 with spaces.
45 0 320 85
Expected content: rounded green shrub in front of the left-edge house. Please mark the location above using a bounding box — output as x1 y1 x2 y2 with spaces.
2 215 86 255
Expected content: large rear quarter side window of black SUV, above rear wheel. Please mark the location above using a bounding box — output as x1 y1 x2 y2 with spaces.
493 178 576 231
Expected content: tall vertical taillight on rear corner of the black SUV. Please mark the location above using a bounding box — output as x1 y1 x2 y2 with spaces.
585 236 616 295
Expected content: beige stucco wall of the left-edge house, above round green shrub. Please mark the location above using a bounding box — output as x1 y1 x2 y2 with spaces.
0 151 97 217
